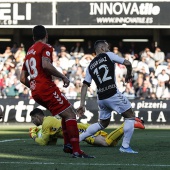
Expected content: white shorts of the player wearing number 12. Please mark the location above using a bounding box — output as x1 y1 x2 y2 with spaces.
97 91 131 120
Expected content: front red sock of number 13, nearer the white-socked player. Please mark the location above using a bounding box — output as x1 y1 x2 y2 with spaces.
66 119 82 153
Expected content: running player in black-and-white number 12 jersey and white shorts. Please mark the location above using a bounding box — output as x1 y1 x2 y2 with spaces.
77 40 138 153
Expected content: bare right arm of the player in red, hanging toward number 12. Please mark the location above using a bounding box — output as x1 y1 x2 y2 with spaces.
42 57 70 87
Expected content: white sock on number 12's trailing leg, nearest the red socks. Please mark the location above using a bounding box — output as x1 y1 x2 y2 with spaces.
79 123 104 142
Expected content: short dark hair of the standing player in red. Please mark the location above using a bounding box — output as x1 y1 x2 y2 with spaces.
32 25 47 41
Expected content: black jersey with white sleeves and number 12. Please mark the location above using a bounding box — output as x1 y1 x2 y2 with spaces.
83 52 125 100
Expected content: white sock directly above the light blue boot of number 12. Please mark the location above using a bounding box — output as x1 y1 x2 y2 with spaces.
122 119 135 148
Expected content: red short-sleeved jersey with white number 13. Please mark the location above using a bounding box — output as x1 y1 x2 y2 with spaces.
22 42 56 95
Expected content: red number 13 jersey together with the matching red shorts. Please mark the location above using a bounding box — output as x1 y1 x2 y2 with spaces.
22 42 71 116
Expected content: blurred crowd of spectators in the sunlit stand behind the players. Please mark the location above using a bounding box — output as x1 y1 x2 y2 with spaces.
0 41 170 100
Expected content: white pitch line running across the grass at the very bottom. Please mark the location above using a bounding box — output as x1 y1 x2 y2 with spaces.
0 162 170 167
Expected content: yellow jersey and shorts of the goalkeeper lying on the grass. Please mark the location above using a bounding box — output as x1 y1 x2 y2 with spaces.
35 116 107 145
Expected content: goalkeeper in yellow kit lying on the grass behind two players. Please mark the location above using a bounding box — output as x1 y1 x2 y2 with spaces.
29 108 145 149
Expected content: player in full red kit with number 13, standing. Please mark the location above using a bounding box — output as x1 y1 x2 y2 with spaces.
20 25 94 158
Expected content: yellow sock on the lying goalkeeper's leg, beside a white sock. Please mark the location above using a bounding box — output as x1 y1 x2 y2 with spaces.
105 123 124 146
